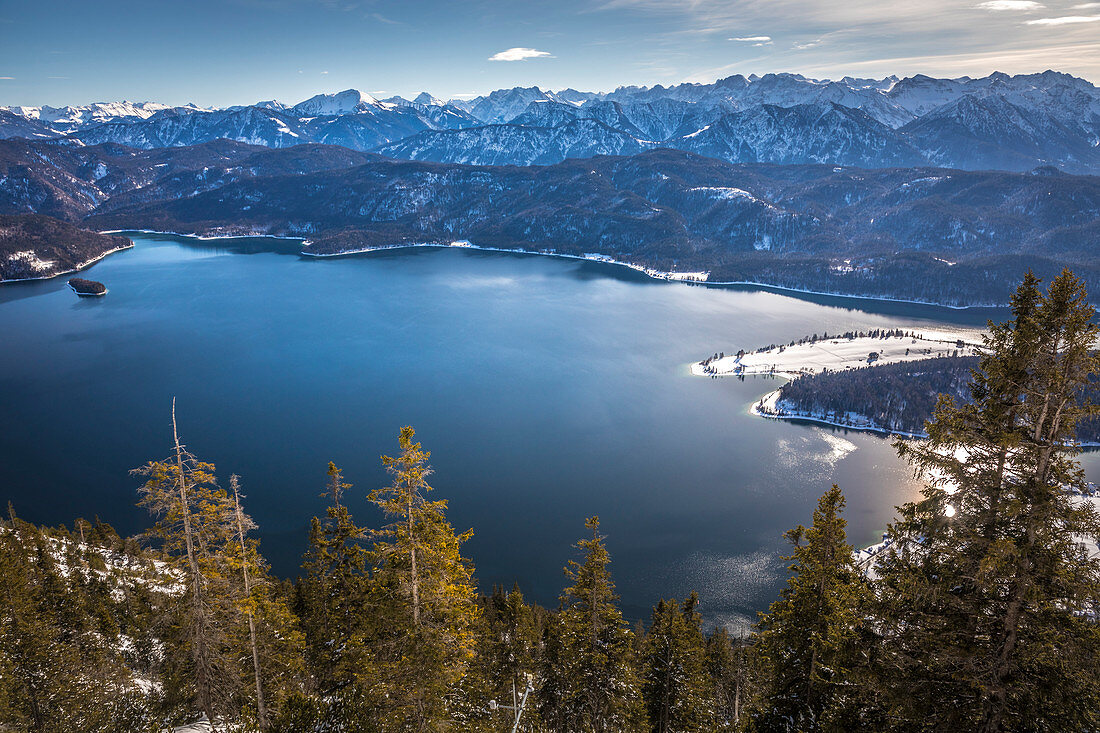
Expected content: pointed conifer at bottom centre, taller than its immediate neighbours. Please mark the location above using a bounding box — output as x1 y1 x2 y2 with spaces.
538 516 645 731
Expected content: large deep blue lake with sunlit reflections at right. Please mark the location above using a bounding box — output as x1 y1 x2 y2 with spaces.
0 236 1073 621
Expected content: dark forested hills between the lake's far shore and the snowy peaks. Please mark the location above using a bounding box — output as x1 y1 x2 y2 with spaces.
0 140 1100 305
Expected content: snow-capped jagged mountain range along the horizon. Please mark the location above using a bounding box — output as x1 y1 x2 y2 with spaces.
0 72 1100 173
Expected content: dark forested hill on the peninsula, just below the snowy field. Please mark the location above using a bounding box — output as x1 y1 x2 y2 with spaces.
776 357 1100 444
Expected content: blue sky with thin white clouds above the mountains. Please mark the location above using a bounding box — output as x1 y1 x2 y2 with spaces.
0 0 1100 107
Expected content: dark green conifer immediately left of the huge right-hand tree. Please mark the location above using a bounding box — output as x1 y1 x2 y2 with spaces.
748 485 866 732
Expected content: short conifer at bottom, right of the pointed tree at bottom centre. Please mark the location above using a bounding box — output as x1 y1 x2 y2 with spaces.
642 593 715 733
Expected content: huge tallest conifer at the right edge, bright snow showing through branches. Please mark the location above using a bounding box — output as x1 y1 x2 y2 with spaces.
877 272 1100 733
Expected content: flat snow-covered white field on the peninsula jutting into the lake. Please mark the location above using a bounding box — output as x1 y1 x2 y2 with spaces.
691 329 980 379
